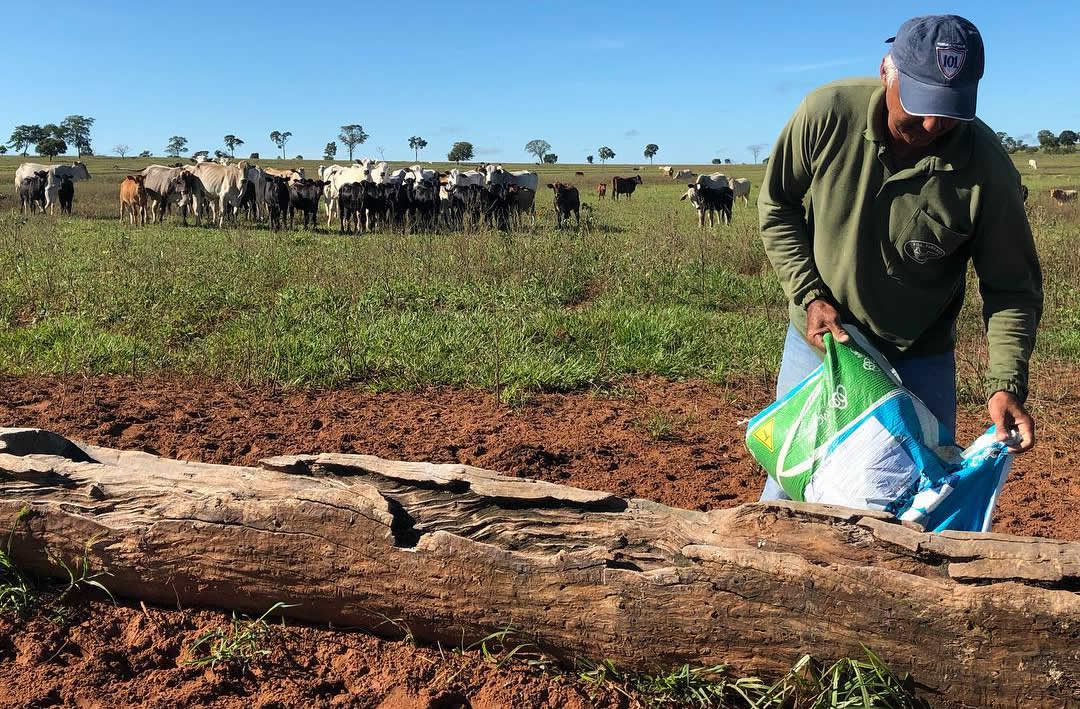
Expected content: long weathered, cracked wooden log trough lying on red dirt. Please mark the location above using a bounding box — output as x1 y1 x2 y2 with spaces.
0 428 1080 708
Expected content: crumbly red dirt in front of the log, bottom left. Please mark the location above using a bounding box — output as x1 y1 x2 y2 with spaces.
0 601 617 709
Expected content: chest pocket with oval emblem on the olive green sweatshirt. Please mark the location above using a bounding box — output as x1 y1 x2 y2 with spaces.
882 208 971 283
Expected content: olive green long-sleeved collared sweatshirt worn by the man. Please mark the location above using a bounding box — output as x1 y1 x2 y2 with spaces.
757 79 1042 401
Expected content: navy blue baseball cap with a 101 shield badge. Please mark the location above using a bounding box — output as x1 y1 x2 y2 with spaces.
886 15 984 121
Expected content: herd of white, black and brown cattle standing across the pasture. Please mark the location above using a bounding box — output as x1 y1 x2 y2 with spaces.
15 159 751 233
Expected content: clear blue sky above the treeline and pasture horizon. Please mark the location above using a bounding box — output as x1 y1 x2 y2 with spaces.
0 0 1080 164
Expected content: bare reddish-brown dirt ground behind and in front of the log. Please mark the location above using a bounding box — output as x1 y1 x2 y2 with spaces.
0 377 1080 709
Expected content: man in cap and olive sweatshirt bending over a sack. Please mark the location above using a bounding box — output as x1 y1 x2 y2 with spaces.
758 15 1042 499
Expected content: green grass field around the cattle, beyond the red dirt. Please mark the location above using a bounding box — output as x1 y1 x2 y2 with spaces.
0 155 1080 401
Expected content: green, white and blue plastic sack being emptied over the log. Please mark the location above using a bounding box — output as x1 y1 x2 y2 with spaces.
746 330 1012 532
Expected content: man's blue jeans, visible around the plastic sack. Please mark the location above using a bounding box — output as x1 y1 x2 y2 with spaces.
760 324 956 501
